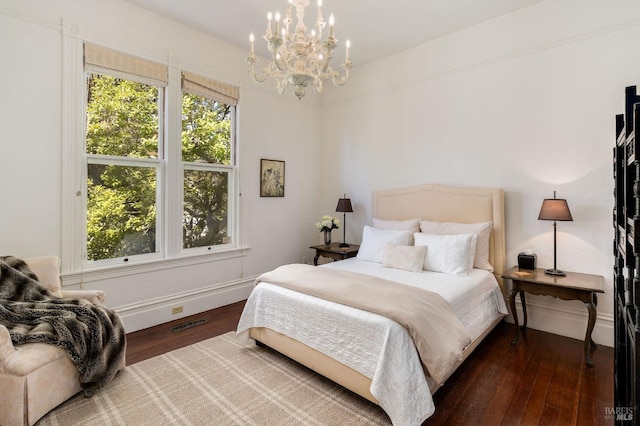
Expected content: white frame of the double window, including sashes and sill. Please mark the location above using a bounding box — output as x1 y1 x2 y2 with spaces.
61 27 241 285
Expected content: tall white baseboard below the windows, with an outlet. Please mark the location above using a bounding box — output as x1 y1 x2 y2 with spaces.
114 277 256 333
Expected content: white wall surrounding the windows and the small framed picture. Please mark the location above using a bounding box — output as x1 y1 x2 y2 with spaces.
0 0 322 331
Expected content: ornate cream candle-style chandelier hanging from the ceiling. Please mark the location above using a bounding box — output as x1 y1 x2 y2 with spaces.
247 0 352 99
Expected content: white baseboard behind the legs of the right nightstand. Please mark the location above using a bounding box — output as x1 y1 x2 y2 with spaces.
507 295 614 347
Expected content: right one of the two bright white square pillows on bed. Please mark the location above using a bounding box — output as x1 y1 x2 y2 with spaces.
414 233 478 275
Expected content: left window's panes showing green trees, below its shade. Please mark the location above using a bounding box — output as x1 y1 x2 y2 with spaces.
86 73 163 262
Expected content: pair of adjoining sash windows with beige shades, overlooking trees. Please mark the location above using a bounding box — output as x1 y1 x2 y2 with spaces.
82 43 238 266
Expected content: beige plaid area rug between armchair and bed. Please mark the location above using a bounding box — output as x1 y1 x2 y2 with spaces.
37 332 391 426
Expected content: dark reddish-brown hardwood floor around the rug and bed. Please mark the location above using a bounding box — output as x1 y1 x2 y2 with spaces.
127 302 613 426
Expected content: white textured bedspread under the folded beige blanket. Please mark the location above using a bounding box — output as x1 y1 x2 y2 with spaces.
237 258 507 426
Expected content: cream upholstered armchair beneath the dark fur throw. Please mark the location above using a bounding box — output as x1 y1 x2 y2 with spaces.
0 256 125 426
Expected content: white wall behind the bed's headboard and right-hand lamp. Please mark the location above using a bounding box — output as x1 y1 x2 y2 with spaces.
322 0 640 345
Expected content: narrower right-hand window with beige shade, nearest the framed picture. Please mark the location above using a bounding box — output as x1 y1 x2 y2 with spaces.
181 72 235 249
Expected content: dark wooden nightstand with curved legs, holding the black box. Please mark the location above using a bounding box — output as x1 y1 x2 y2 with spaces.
502 266 604 367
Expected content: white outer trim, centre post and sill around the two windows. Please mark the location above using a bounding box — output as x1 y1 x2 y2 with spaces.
60 19 245 280
